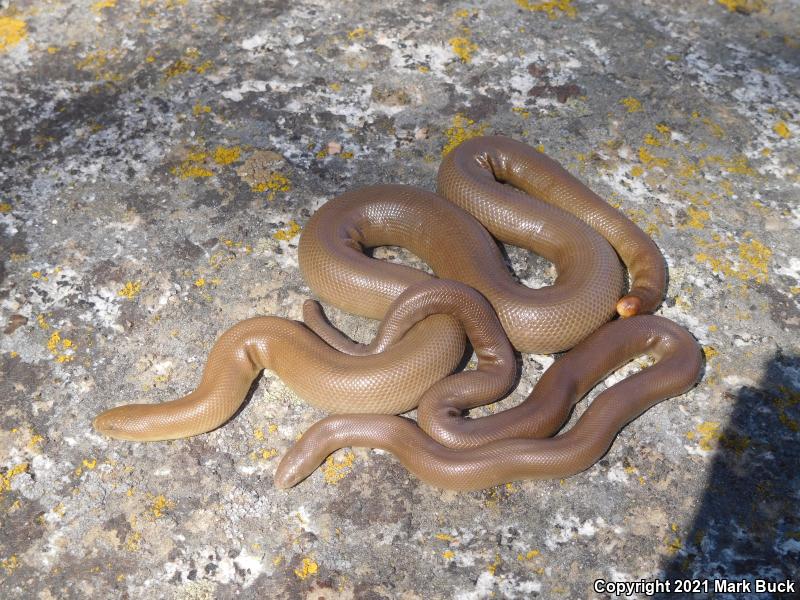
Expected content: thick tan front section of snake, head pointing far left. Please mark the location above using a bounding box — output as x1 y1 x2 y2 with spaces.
94 296 468 441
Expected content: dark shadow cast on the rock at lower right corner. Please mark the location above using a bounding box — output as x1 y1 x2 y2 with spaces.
654 353 800 599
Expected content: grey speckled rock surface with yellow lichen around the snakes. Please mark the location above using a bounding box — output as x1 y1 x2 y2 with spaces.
0 0 800 600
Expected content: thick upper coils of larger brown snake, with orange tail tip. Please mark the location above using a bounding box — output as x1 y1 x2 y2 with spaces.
298 137 666 353
